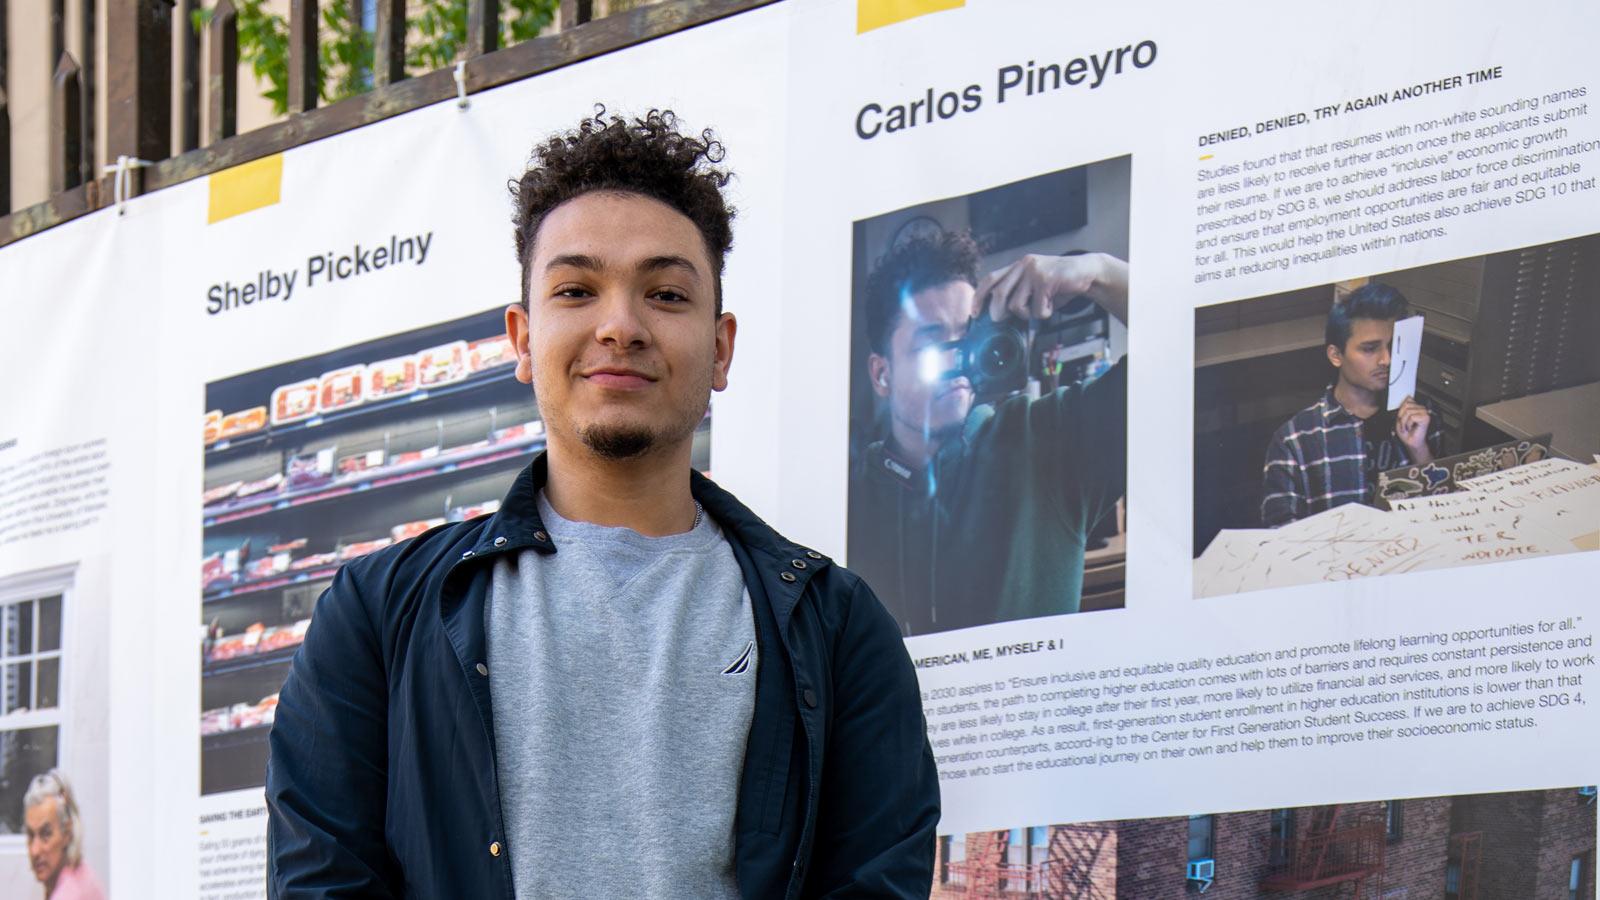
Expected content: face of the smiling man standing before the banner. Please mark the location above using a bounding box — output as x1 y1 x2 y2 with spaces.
506 192 736 458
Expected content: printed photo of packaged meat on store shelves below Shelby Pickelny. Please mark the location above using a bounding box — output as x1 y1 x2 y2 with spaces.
200 309 710 794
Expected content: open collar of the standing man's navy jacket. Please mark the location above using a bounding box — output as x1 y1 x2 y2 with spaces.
472 453 832 633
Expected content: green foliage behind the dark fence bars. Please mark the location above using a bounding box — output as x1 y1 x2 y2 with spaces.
192 0 560 115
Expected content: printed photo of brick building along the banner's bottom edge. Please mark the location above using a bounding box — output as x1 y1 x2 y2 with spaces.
931 788 1595 900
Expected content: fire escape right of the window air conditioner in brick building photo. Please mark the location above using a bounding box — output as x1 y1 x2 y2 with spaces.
1261 806 1387 898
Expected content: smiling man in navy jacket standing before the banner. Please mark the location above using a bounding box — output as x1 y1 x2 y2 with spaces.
267 110 939 898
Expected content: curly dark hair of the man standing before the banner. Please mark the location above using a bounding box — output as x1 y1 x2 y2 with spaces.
510 104 733 315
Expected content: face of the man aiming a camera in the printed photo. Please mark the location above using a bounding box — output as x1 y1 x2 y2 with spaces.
869 280 974 439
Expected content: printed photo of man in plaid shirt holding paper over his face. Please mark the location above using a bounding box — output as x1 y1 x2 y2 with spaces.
1194 235 1600 597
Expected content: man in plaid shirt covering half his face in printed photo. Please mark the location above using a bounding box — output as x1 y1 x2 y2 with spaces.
1261 282 1440 528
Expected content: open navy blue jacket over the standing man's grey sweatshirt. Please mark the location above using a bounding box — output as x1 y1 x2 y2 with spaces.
267 456 939 900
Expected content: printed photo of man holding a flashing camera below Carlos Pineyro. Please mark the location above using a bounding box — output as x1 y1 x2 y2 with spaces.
848 167 1128 636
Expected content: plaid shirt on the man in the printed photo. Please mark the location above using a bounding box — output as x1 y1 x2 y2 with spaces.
1261 386 1440 528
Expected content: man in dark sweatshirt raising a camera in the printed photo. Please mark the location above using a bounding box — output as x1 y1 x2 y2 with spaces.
850 232 1128 634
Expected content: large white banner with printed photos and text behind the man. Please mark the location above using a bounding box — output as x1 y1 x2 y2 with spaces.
0 0 1600 900
